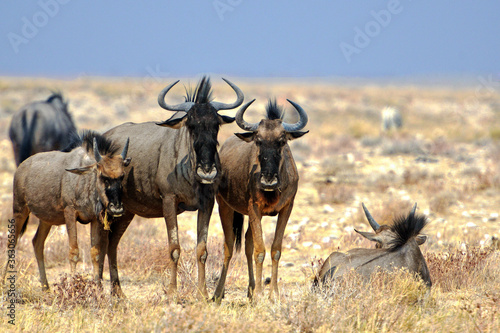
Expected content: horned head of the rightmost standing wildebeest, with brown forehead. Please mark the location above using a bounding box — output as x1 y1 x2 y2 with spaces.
236 99 309 191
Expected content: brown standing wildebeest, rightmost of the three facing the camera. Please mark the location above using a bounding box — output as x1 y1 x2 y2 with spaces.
214 100 307 302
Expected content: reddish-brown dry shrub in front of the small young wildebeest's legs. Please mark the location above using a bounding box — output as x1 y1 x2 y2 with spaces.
53 274 106 309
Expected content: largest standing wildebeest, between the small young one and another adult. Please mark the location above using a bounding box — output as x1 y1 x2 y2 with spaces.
105 77 244 297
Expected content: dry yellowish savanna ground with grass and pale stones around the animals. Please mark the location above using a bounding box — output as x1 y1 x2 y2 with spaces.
0 77 500 332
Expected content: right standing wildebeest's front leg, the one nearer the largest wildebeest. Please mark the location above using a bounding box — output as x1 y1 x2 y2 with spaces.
245 207 266 296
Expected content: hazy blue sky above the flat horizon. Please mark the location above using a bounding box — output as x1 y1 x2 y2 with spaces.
0 0 500 78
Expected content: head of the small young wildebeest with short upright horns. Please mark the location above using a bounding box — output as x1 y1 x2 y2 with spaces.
66 132 131 217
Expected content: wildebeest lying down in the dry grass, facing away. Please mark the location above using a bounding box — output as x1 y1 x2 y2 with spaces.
315 204 432 287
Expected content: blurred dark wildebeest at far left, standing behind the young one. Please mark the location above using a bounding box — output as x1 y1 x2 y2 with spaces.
9 93 76 166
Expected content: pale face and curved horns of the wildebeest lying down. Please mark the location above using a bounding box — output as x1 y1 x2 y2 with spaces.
354 203 427 249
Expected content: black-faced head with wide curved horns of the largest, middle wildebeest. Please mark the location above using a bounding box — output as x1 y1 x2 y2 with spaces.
158 77 244 184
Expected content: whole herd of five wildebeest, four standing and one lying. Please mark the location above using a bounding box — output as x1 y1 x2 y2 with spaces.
4 77 431 302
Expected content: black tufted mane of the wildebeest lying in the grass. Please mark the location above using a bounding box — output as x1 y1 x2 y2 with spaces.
389 214 428 251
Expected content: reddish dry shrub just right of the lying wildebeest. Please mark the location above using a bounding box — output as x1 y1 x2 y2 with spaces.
425 247 493 292
